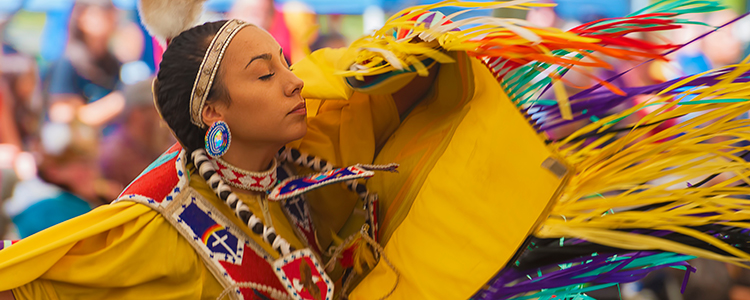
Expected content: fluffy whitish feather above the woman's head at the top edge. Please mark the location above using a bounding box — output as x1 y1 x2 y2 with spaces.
138 0 206 40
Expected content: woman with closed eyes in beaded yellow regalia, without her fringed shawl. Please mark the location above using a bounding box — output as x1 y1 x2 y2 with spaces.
0 3 428 299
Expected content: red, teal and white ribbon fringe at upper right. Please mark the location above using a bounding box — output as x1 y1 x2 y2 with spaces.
496 0 724 120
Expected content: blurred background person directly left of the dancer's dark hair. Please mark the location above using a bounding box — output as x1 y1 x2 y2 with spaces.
99 80 175 187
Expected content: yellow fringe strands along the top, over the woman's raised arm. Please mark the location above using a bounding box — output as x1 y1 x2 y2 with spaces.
336 0 600 80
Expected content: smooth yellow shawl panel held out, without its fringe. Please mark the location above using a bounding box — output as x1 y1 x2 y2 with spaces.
350 54 561 300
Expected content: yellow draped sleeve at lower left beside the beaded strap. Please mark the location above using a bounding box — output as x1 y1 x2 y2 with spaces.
0 202 222 299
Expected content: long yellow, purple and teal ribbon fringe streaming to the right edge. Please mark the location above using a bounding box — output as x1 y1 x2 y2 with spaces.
476 1 750 299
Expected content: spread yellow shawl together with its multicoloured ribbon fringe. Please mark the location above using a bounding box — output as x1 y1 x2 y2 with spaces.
294 5 750 300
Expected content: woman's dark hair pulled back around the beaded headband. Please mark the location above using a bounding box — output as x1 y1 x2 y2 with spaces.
154 21 229 153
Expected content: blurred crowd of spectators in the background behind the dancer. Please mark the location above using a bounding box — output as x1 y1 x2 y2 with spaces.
0 0 750 300
